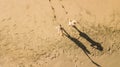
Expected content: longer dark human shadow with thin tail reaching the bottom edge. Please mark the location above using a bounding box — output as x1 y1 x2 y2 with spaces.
62 28 101 67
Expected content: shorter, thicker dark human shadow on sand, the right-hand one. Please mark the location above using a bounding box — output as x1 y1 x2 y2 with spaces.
73 26 103 51
